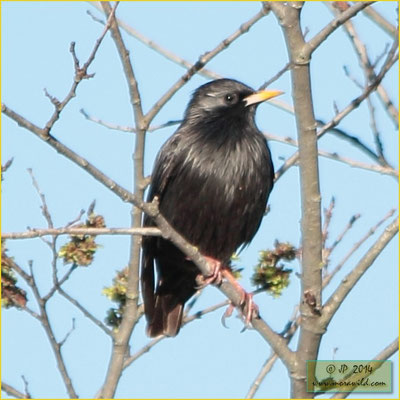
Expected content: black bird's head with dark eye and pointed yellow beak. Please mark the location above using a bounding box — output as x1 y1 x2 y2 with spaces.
185 79 283 122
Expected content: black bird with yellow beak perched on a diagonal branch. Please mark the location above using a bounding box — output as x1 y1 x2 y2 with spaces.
141 79 282 337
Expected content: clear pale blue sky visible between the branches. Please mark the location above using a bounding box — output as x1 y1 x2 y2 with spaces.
1 2 398 398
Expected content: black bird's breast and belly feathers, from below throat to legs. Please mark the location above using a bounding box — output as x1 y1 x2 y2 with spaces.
160 126 272 261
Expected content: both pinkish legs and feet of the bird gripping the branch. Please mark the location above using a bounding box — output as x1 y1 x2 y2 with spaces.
197 256 259 326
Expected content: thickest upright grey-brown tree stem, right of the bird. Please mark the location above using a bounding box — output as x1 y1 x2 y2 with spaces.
271 2 324 398
